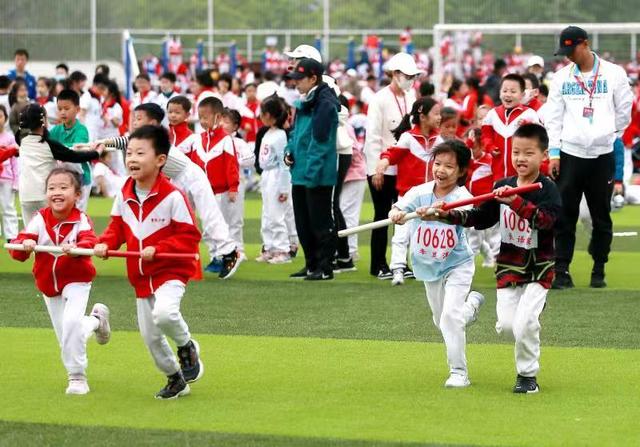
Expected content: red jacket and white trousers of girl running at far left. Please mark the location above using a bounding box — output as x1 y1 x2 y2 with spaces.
9 208 99 375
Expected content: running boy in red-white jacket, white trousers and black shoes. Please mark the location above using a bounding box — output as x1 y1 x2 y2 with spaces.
94 126 204 399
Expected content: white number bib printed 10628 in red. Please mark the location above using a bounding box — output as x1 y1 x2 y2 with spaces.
412 222 458 262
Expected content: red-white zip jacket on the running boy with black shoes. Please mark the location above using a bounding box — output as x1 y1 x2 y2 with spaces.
99 173 200 298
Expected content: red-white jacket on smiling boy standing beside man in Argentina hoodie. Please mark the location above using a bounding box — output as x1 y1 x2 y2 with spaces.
481 104 540 181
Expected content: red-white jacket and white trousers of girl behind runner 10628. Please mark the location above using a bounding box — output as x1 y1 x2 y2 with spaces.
380 125 442 271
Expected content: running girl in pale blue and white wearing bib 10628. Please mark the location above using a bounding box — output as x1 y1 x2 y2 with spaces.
389 140 484 388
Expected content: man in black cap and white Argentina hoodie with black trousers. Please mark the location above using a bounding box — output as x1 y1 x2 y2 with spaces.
545 26 633 289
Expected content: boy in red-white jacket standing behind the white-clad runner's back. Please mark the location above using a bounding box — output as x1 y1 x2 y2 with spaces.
190 97 240 231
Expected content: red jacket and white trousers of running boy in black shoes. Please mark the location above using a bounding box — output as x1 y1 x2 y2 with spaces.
99 174 200 376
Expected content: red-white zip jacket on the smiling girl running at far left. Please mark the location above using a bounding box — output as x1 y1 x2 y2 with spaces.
9 208 97 297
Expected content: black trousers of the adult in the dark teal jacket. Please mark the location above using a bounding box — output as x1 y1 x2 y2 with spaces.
291 185 336 273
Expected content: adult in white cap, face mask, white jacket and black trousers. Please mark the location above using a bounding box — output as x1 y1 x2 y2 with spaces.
364 53 421 279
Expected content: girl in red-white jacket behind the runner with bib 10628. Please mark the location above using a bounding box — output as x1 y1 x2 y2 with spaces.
373 97 441 286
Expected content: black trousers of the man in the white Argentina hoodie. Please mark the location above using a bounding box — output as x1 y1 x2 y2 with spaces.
556 152 615 271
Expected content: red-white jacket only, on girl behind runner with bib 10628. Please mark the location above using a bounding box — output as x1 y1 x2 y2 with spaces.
380 125 441 196
